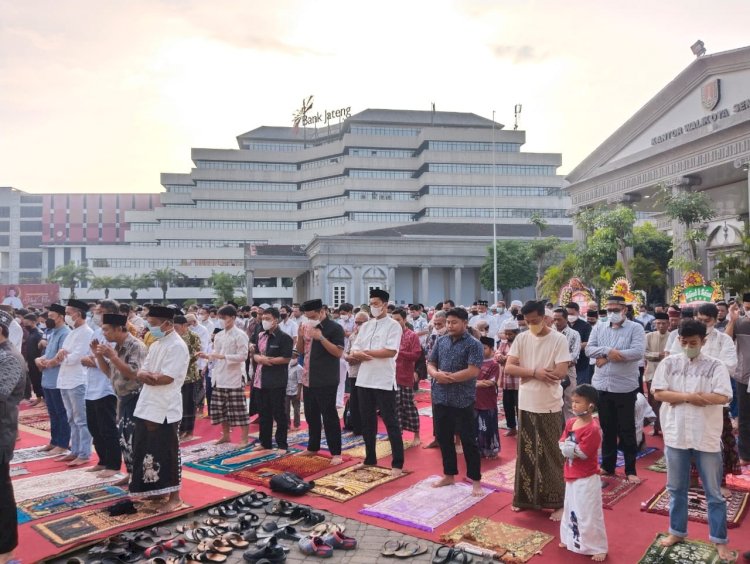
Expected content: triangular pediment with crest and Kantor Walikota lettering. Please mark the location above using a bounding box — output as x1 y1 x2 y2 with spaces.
567 47 750 184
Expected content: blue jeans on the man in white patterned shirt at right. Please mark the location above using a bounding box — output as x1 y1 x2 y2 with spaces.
665 447 728 544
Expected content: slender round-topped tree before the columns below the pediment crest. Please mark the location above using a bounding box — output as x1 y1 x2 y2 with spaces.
661 187 716 270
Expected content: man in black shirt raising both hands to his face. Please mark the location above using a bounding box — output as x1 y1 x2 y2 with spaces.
297 300 344 465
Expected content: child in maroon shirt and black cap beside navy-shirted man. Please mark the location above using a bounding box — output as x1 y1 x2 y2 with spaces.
474 337 500 458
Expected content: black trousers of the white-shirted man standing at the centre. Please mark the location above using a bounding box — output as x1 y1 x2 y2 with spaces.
356 386 404 468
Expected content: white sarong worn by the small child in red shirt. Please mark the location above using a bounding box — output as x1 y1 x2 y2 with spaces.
560 474 608 554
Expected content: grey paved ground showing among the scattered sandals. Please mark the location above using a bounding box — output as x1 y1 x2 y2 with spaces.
49 496 440 564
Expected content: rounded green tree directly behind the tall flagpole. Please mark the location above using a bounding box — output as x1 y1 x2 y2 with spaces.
479 240 535 302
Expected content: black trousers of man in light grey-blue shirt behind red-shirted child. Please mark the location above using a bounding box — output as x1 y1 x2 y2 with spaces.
598 390 638 476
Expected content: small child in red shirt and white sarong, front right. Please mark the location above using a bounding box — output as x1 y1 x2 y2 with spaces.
560 384 608 562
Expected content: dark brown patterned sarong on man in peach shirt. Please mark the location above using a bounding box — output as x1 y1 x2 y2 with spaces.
513 410 565 509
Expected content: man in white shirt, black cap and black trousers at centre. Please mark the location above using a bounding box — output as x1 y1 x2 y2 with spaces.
349 289 404 476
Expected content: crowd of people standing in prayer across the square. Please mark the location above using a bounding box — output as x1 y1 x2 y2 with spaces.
0 289 750 560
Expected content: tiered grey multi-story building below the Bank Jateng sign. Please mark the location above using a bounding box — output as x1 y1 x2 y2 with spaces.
87 110 572 304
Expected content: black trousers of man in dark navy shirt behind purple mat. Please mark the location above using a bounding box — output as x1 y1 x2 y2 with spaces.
432 404 482 480
